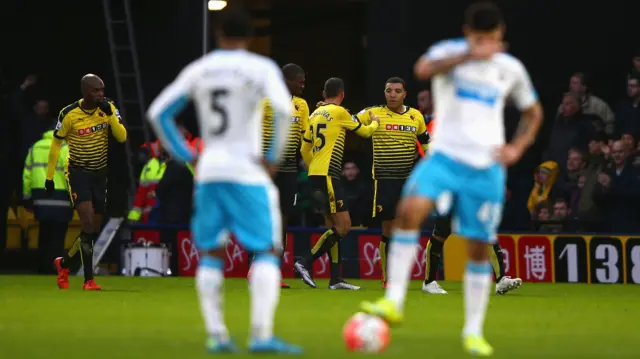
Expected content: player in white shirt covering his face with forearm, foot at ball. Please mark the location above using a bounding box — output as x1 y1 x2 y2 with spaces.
362 2 542 356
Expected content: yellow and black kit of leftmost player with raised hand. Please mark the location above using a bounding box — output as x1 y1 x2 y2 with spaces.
47 100 127 213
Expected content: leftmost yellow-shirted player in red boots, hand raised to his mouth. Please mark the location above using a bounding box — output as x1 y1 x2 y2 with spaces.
45 74 127 290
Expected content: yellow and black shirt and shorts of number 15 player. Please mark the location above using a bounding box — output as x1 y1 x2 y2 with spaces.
301 104 378 214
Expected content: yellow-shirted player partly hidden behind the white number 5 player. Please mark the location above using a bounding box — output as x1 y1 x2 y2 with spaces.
262 64 309 288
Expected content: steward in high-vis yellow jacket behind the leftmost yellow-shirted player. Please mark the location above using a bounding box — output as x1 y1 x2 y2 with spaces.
22 131 73 273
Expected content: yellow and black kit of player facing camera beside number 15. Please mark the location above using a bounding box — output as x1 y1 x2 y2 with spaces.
356 106 429 221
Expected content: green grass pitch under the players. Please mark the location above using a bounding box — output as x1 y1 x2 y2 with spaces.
0 276 640 359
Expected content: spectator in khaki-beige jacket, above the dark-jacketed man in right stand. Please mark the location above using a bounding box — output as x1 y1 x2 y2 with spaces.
558 72 615 134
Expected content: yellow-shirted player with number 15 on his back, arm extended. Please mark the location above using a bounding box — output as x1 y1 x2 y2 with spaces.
294 77 379 290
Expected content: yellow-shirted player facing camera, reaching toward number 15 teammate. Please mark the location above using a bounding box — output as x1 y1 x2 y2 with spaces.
356 77 429 286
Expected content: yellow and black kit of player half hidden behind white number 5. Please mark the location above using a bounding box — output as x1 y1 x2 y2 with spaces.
262 96 309 216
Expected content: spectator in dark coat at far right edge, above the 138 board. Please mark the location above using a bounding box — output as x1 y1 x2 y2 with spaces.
593 141 640 233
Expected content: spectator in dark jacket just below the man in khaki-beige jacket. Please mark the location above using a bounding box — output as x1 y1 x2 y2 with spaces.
544 93 601 172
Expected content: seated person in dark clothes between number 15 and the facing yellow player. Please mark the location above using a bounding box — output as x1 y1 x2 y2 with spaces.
342 161 372 226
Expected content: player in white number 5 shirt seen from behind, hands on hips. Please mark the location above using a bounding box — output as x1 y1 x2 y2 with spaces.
148 6 301 353
